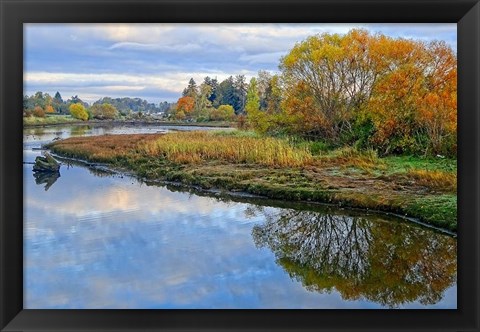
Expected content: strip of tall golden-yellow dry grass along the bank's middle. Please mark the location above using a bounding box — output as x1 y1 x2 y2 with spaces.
144 132 313 167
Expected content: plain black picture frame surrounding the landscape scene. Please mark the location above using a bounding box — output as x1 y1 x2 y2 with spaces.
0 0 480 331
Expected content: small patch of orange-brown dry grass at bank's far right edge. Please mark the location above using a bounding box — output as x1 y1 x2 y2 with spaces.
407 169 457 193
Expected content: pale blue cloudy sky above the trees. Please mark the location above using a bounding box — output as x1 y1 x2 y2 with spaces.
24 23 457 103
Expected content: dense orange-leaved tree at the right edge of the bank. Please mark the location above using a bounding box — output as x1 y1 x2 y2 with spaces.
364 37 457 154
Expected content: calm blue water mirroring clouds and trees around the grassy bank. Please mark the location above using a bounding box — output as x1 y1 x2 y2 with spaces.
24 126 457 309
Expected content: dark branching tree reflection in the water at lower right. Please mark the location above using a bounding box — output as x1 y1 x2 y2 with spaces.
250 209 457 308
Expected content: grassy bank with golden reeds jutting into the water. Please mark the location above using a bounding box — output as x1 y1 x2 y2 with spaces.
49 132 457 231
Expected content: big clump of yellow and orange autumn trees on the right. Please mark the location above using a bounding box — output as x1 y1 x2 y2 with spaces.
280 30 457 155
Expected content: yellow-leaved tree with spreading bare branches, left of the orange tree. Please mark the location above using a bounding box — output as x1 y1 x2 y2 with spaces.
280 30 378 140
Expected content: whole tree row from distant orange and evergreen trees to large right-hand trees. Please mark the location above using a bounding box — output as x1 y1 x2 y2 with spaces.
171 29 457 156
